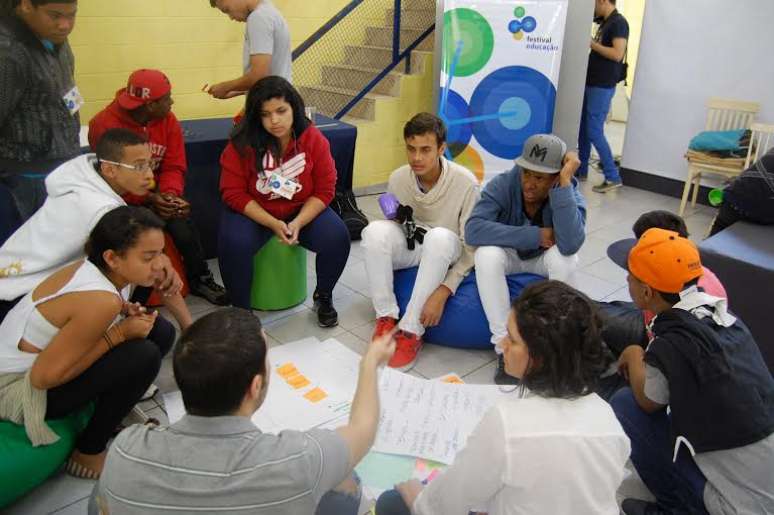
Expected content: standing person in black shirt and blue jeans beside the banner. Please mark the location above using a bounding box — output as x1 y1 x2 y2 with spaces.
577 0 629 193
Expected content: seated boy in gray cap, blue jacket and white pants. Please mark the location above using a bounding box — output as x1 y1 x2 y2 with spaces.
465 134 586 384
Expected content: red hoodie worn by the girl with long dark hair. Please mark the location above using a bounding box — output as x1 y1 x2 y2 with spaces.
220 125 336 220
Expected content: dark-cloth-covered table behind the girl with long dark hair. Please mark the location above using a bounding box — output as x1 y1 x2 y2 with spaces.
180 114 357 258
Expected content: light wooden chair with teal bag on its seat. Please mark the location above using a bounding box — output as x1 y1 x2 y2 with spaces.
679 98 760 216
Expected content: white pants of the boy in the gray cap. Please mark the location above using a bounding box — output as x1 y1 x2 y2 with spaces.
476 245 578 346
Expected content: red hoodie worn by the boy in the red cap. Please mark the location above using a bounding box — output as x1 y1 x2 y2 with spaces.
89 100 188 204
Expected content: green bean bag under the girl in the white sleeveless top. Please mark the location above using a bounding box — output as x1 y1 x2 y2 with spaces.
0 404 94 508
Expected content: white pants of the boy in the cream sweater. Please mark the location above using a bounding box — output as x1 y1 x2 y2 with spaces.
362 220 462 336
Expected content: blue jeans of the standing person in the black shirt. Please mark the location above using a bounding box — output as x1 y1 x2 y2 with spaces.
577 86 621 182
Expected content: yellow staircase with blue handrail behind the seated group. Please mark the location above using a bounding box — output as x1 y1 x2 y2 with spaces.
293 0 436 187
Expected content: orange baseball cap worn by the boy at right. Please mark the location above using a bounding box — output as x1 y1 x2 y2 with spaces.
628 228 704 293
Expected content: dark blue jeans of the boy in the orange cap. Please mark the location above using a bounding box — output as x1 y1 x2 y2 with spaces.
610 388 707 515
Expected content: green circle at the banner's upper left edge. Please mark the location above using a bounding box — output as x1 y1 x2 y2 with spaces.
442 8 494 77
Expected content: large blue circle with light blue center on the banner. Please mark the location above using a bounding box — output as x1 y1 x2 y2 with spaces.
470 66 556 159
